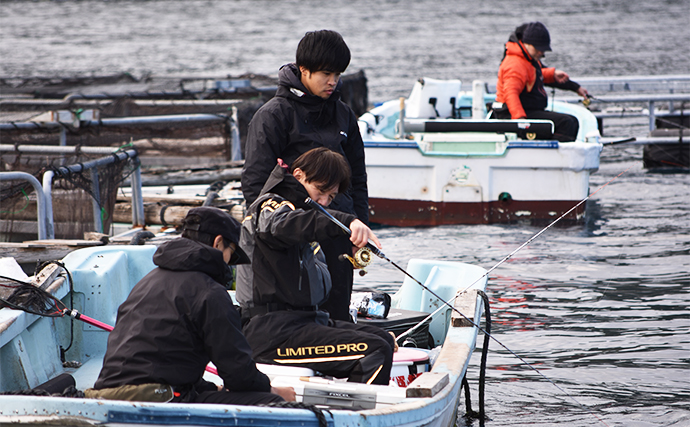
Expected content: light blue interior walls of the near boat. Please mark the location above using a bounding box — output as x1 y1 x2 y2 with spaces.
0 245 484 391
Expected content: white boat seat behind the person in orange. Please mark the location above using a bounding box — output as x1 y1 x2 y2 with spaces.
405 77 462 119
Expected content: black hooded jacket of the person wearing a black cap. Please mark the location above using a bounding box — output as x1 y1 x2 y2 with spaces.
94 238 271 392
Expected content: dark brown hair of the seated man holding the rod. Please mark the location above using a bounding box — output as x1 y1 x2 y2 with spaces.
290 147 351 193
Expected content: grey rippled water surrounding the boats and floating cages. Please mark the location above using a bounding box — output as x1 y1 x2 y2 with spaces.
0 0 690 427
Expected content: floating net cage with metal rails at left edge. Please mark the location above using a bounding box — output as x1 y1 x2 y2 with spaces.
0 149 139 242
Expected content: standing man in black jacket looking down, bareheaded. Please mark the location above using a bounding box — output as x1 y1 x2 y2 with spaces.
242 30 369 320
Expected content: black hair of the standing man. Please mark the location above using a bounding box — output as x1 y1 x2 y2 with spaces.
295 30 350 73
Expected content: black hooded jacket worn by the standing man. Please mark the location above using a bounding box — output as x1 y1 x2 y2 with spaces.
242 64 369 224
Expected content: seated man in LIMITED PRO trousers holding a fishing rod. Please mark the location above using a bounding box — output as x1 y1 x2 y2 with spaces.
237 147 395 385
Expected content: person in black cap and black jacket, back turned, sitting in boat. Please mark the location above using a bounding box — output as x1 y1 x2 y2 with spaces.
86 207 295 405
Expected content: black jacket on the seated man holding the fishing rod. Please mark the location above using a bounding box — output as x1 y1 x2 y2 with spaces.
236 166 355 308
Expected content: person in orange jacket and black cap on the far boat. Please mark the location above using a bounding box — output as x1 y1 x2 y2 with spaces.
493 22 588 141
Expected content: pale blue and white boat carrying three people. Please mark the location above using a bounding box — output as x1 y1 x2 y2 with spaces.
0 245 486 426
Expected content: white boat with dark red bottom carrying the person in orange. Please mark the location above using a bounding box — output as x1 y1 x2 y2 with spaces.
360 78 602 226
